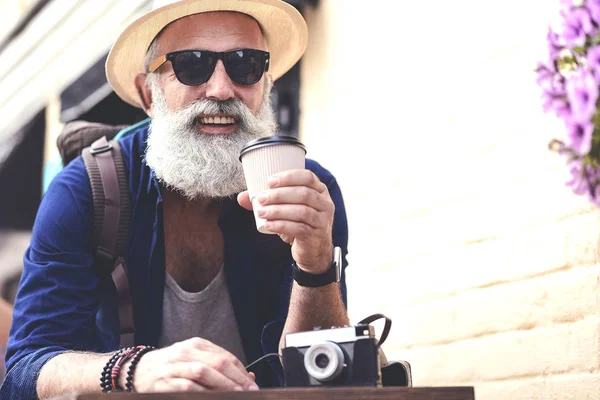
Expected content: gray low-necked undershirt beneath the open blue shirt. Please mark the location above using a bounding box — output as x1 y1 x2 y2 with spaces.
158 268 246 365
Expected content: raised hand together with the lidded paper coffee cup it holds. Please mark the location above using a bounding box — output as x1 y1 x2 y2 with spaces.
238 136 335 274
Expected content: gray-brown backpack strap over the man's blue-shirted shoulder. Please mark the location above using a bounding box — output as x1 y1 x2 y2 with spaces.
82 137 135 347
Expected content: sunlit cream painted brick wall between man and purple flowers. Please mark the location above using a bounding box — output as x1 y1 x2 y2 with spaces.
301 0 600 400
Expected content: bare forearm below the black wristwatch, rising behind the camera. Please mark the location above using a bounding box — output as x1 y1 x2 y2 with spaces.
279 282 349 349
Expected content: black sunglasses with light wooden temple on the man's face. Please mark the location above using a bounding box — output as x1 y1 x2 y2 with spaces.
150 49 270 86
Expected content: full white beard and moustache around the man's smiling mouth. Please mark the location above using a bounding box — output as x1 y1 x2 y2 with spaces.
145 74 277 200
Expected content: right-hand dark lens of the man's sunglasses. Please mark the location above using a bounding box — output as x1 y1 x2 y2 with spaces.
223 49 267 85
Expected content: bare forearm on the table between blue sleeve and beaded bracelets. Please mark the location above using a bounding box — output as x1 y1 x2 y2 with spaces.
37 352 113 400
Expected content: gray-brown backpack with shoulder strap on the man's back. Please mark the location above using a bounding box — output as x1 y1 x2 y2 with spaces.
53 119 149 347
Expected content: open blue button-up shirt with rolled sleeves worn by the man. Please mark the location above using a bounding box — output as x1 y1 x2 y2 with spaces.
0 126 348 399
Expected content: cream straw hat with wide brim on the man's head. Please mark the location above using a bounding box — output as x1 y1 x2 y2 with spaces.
106 0 308 108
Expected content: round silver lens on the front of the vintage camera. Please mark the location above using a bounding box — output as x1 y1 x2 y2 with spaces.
304 342 346 382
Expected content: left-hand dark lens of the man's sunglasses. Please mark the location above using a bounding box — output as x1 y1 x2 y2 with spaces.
172 51 217 86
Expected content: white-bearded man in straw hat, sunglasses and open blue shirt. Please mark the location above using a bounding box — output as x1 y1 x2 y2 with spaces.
1 0 348 399
